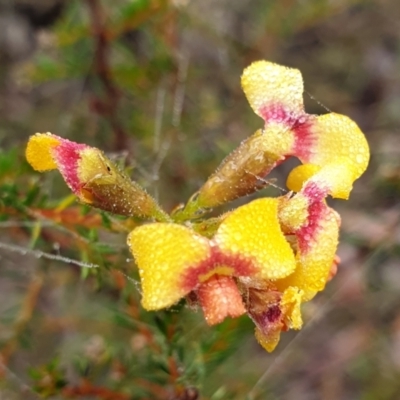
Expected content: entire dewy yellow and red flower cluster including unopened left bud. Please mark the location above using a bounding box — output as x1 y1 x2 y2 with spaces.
26 61 369 351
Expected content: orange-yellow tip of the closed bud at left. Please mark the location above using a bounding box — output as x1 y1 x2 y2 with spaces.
25 133 60 171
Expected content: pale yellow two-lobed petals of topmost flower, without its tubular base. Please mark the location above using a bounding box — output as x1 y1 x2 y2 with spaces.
242 61 369 199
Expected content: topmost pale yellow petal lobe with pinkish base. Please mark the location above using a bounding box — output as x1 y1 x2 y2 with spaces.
242 61 304 122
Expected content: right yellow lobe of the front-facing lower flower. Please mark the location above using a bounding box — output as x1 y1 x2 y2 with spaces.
214 199 295 280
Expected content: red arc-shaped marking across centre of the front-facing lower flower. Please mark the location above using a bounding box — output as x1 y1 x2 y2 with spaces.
182 247 257 291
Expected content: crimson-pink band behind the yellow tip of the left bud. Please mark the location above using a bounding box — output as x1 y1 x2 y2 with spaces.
51 138 89 193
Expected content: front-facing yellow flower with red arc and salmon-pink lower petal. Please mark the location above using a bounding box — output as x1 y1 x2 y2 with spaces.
128 199 302 344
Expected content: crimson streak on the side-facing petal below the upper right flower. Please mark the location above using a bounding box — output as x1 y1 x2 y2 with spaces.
295 182 327 253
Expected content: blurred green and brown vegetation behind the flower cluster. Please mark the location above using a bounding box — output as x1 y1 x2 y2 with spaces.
0 0 400 400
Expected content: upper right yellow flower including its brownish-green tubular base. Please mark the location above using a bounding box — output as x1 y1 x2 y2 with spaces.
192 61 369 208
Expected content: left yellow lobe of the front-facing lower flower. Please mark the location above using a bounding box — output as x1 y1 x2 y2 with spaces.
128 223 210 310
